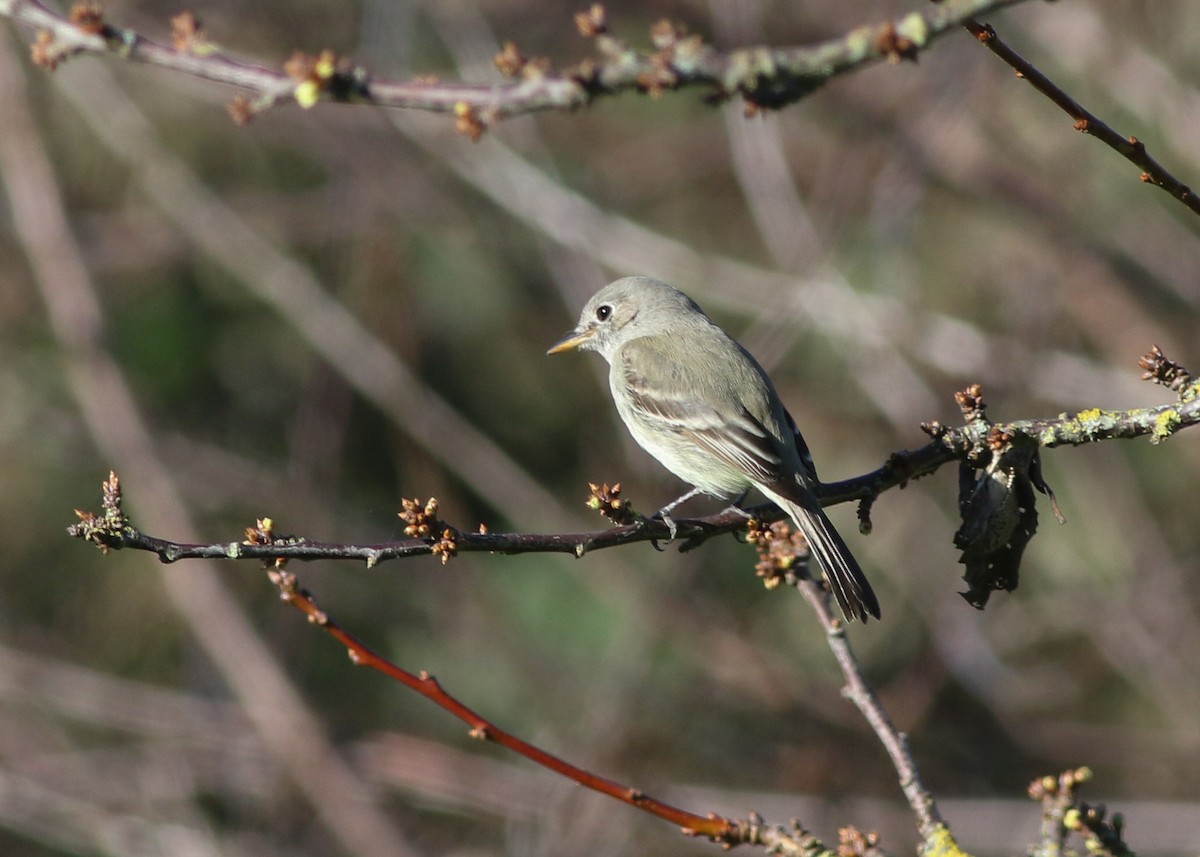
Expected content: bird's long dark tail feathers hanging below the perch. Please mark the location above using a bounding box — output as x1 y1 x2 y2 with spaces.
760 483 880 622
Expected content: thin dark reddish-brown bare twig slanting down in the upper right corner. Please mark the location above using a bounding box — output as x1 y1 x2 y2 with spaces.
962 18 1200 214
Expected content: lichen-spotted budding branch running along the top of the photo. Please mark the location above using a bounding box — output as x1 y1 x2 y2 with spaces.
0 0 1024 121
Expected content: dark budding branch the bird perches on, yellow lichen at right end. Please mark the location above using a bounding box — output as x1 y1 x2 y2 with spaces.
68 367 1200 567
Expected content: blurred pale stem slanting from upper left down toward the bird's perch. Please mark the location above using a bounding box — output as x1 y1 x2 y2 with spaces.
46 43 570 526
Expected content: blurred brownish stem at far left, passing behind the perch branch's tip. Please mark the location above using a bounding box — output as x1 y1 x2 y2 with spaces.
0 33 414 857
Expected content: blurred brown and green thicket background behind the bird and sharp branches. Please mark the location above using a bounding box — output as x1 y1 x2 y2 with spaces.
0 0 1200 857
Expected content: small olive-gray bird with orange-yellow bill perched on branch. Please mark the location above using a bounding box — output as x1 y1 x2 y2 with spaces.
547 277 880 622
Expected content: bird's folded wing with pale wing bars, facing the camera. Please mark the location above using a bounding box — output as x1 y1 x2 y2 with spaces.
614 337 786 483
